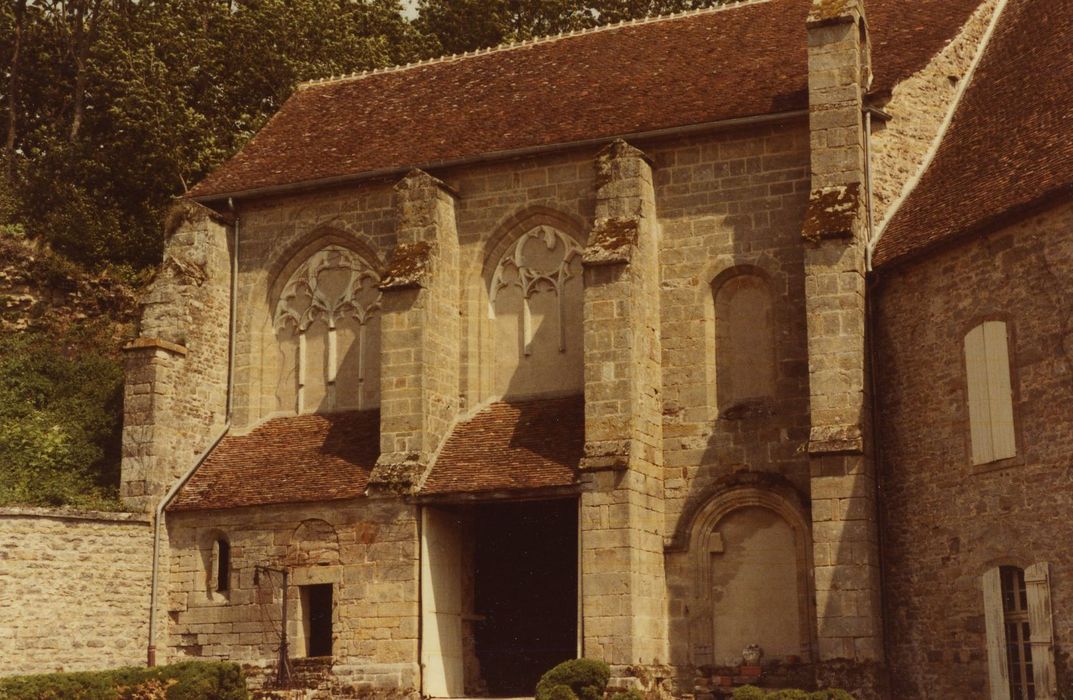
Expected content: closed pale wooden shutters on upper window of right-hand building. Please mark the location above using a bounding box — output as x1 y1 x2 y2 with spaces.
965 321 1017 465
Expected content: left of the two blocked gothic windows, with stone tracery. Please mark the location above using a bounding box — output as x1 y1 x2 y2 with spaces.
274 245 380 413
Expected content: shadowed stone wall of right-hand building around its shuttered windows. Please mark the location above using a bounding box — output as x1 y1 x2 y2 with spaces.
877 199 1073 700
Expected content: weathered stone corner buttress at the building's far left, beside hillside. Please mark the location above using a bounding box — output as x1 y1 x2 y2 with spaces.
119 202 232 511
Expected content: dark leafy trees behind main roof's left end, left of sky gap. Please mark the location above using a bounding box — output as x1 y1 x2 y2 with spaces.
0 0 430 267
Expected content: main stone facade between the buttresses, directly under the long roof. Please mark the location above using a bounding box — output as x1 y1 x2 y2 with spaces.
215 124 809 687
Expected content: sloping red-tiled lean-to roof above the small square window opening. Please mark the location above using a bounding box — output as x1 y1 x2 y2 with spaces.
168 411 380 511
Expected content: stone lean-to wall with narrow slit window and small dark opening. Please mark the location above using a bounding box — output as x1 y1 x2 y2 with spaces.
164 499 421 691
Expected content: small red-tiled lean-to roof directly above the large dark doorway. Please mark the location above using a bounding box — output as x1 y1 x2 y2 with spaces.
421 396 585 495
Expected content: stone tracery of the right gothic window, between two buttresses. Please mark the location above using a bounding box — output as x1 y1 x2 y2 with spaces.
488 225 583 355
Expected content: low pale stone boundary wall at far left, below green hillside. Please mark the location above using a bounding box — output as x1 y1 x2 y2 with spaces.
0 508 152 675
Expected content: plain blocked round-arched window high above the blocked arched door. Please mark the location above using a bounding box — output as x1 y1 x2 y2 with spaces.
705 264 780 420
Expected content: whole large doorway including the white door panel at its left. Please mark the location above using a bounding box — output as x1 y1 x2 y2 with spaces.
422 498 578 698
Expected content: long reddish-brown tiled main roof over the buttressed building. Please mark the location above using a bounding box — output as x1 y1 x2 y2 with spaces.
191 0 980 199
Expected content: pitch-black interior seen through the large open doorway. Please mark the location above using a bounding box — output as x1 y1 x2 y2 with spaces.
473 499 577 697
